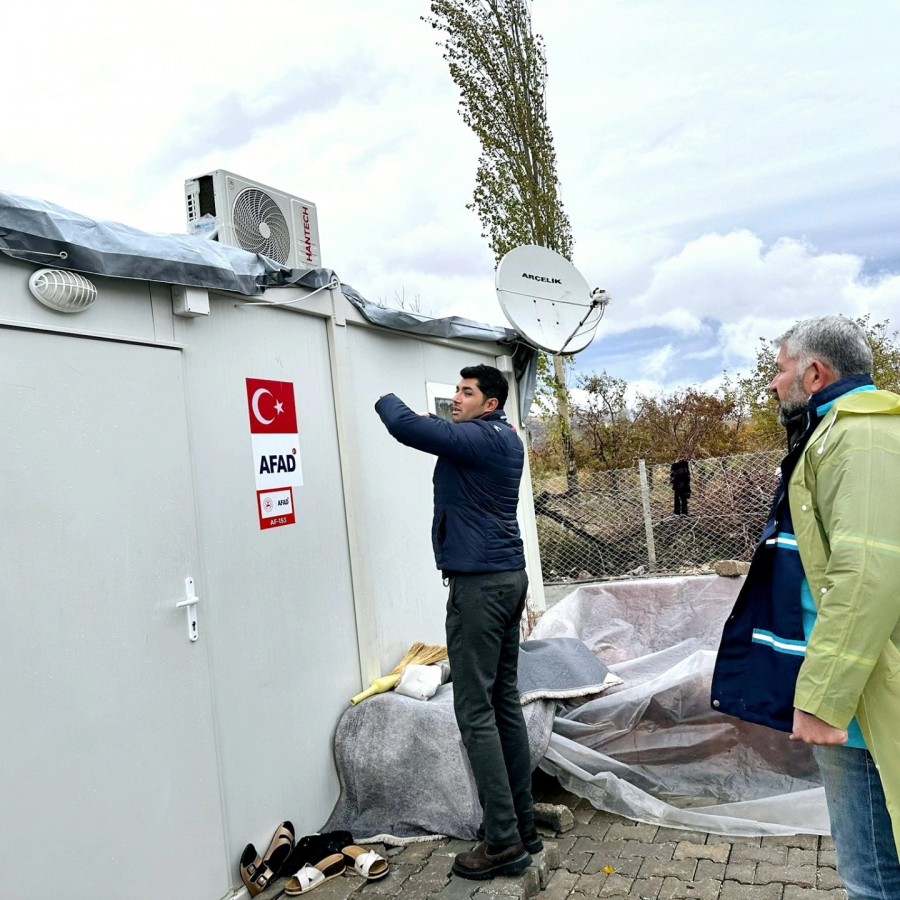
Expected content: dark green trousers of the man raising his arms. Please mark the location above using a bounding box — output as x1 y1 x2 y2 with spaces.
447 569 534 847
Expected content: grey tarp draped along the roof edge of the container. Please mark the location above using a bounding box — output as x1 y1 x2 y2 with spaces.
0 192 537 420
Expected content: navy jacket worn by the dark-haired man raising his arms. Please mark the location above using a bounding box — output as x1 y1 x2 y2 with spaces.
375 394 525 573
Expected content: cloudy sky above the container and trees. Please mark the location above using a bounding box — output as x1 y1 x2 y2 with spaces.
7 0 900 390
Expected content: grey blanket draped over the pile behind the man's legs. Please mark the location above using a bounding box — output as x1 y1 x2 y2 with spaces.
322 638 619 844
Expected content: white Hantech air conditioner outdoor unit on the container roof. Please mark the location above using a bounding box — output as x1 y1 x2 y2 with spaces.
184 169 322 269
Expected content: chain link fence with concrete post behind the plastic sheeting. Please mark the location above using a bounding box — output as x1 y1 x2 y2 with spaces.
534 450 784 584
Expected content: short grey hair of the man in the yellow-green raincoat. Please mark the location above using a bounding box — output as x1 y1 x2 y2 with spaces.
775 316 872 378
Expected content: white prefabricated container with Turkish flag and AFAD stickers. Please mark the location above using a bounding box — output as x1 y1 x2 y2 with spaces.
0 206 543 900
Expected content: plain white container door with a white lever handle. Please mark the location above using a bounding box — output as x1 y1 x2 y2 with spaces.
0 327 230 900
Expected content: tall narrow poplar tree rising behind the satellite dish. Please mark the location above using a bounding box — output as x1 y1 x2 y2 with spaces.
423 0 577 488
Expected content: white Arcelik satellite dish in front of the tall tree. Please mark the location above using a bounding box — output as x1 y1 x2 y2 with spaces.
496 244 609 354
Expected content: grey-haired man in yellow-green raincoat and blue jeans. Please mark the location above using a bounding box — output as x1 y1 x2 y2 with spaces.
712 316 900 900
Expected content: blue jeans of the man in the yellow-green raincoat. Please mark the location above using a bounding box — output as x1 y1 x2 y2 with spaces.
812 747 900 900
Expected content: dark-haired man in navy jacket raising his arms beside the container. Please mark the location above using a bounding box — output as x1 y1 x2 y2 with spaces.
375 365 543 879
